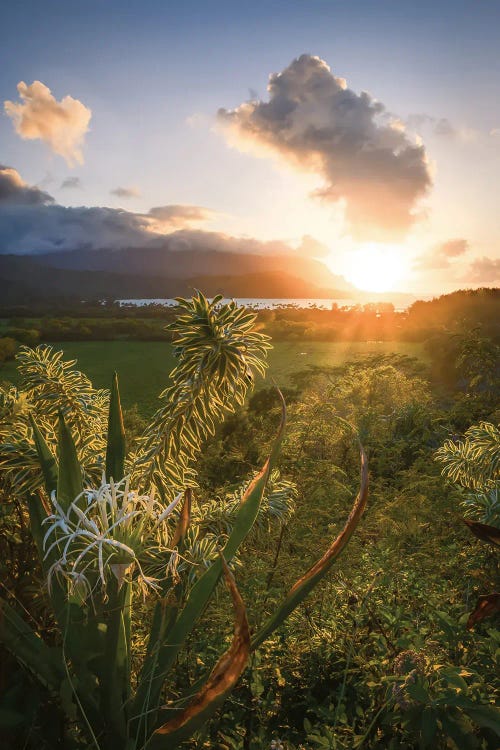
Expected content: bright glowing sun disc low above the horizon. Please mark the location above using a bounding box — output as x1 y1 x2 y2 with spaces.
345 242 409 292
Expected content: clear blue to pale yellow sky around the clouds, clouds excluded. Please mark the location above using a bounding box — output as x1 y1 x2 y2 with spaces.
0 0 500 290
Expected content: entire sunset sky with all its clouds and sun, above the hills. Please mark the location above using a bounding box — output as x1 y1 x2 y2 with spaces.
0 0 500 293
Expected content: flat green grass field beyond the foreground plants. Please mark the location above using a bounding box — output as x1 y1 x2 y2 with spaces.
0 341 425 416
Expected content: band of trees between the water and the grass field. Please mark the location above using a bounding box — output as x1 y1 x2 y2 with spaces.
0 289 500 359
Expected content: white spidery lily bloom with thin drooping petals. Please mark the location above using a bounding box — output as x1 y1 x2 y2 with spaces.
43 476 183 602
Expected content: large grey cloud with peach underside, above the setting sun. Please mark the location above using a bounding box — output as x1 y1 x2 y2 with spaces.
218 55 431 239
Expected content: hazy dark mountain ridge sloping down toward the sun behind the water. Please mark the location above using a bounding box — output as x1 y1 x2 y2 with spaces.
0 249 355 304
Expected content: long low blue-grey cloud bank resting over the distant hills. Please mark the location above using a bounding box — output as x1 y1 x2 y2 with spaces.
0 167 294 255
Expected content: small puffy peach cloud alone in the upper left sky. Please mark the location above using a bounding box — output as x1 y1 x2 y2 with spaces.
4 81 92 166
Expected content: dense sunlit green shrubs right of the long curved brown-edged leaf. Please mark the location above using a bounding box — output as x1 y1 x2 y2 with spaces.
200 357 500 750
